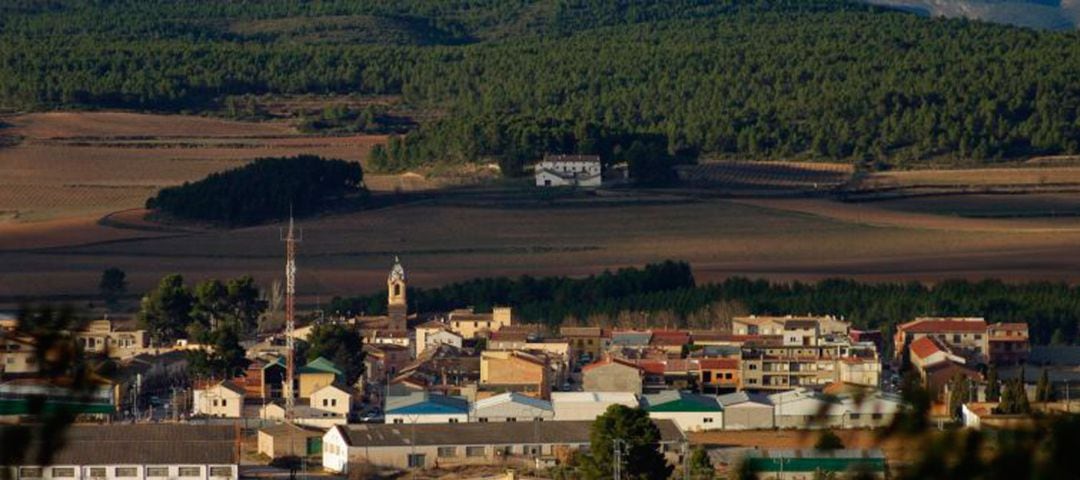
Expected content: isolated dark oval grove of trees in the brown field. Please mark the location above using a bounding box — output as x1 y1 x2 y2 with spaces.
146 155 366 226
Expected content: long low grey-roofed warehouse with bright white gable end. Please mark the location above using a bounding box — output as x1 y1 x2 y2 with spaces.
323 421 686 474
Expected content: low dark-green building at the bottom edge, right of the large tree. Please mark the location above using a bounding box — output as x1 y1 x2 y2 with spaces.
744 450 886 480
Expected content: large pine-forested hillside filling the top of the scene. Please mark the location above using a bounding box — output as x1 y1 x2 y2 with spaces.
0 0 1080 169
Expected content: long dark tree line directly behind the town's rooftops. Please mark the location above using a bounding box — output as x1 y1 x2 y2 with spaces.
330 262 1080 344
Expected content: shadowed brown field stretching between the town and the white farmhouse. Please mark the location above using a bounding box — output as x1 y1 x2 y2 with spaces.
6 190 1080 308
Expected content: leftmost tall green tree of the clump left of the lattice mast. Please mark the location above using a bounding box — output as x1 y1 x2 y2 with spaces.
138 274 194 345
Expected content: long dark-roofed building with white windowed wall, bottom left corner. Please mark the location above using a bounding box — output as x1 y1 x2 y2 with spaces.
0 424 240 480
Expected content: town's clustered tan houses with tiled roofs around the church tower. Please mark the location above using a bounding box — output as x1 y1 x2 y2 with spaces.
0 258 1058 479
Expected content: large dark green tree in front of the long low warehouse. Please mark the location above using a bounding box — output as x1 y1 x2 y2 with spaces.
581 404 674 480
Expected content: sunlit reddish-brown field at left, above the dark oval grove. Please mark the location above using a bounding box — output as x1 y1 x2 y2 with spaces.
0 112 393 223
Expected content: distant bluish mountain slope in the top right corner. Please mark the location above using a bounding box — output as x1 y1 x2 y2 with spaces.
864 0 1080 30
